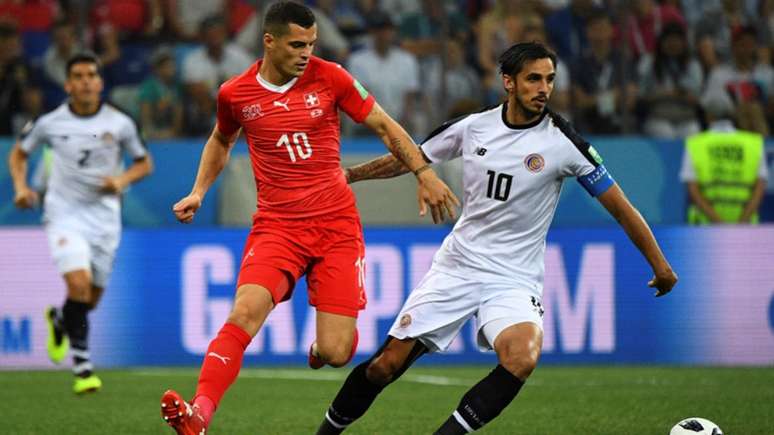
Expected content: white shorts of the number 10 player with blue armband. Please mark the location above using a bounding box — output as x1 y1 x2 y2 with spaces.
389 269 543 352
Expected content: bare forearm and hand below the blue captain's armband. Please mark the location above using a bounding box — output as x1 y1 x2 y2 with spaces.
597 183 677 296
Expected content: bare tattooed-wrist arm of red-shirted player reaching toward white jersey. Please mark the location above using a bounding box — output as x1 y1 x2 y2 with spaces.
365 103 460 223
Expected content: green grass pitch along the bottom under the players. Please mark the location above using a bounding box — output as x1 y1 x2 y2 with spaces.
0 365 774 435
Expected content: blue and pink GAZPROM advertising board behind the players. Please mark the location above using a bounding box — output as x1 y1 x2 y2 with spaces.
0 226 774 367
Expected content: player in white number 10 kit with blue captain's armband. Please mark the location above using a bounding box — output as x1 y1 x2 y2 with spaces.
318 43 677 435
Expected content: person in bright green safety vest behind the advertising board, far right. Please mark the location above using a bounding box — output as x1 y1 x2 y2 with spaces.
680 93 768 225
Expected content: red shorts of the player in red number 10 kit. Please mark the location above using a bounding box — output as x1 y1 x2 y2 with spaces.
237 214 366 317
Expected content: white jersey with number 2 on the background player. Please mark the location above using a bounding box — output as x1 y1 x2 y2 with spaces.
21 103 146 233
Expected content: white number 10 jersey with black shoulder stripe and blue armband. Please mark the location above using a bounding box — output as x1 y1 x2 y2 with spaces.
422 104 613 294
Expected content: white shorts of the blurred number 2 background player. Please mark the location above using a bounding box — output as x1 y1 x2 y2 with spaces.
46 224 120 288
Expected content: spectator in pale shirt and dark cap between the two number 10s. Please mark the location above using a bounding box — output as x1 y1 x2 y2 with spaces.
347 12 419 133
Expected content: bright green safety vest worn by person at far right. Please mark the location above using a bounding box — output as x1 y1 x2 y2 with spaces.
685 131 763 225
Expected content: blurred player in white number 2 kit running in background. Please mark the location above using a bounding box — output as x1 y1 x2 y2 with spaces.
8 53 152 394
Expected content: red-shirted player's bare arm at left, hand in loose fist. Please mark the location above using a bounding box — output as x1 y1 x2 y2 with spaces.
172 125 241 224
